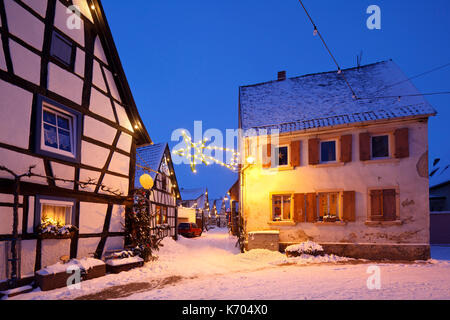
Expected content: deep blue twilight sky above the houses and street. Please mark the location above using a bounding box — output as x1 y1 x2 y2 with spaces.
102 0 450 197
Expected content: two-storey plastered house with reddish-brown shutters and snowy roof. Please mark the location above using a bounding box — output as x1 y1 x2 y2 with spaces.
239 61 436 260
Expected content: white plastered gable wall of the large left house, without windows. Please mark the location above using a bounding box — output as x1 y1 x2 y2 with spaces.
0 0 138 281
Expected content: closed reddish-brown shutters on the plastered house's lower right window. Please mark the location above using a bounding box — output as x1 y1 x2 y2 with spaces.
369 189 397 221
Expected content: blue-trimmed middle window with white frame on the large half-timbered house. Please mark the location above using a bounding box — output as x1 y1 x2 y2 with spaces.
35 96 81 162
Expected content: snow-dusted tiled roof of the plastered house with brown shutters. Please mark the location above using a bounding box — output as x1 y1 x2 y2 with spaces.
240 60 436 133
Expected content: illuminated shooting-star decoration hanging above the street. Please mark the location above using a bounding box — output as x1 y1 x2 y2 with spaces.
173 131 240 173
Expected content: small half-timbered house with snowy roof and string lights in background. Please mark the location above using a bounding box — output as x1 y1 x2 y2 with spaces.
135 143 181 237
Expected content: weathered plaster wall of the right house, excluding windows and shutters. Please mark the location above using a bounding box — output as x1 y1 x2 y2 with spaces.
241 121 430 258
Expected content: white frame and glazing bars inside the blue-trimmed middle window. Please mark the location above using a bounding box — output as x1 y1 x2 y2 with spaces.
40 102 77 159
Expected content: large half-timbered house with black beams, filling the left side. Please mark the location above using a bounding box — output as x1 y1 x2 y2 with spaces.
0 0 151 288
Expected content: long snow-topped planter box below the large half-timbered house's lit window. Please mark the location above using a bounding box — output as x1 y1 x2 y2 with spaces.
36 258 106 291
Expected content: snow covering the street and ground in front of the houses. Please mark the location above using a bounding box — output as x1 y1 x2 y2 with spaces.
8 229 450 300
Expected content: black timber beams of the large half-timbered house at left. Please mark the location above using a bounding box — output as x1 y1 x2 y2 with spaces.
0 0 152 289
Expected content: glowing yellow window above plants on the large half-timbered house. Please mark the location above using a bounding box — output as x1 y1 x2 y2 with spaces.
40 199 73 227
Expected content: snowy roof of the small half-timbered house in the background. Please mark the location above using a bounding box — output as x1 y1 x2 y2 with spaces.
134 143 167 182
